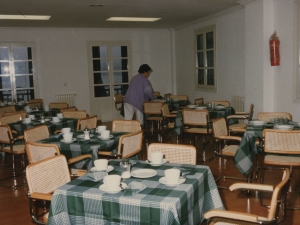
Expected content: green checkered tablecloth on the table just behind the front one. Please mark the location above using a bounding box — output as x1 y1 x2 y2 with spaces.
39 131 128 169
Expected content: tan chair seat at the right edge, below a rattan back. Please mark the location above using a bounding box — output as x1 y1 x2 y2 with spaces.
264 154 300 166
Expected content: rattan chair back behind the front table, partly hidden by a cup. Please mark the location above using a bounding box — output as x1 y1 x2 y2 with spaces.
147 143 196 165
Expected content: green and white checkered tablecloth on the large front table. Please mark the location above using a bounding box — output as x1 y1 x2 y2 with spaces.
48 160 224 225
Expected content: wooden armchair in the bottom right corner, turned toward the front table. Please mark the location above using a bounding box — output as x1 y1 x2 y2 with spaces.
204 169 290 225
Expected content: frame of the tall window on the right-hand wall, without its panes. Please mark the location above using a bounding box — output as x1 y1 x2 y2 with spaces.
194 24 217 92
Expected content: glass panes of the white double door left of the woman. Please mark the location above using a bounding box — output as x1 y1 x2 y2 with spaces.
90 43 129 98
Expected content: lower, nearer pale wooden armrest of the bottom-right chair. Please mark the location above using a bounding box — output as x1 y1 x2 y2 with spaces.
204 209 258 222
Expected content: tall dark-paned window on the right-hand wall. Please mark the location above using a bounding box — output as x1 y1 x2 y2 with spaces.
195 25 216 91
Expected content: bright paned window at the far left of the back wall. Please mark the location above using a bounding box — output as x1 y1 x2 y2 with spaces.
0 44 35 101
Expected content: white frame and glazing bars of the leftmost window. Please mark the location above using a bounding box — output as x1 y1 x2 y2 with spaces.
0 42 39 100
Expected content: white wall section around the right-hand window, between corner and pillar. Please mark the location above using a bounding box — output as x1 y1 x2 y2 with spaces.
175 9 245 105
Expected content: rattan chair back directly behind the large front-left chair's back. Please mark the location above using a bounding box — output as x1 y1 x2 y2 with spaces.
25 141 60 164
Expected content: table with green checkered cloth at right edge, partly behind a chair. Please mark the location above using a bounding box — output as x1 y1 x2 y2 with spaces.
233 121 300 176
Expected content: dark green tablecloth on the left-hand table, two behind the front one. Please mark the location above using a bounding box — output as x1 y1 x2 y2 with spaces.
8 118 78 135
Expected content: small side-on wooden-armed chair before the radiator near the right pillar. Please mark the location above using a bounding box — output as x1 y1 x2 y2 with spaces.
227 104 254 133
